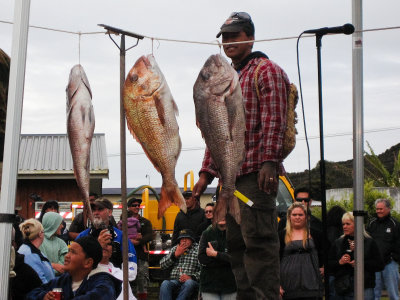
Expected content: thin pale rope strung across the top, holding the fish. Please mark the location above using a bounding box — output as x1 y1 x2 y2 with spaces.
0 20 400 45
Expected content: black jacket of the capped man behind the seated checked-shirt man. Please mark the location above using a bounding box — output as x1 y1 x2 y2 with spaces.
172 207 206 246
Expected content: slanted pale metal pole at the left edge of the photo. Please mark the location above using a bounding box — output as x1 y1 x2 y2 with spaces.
0 0 31 299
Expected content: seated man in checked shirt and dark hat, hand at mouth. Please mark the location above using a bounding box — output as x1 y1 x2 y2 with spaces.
160 229 200 300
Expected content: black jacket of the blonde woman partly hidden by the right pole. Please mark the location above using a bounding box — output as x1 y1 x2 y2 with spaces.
328 236 384 289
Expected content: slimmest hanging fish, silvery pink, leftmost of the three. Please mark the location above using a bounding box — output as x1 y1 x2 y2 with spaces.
66 65 95 223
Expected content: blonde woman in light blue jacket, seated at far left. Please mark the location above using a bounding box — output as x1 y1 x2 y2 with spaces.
18 219 54 283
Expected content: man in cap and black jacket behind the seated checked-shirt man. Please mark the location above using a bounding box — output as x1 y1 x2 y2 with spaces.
172 191 207 246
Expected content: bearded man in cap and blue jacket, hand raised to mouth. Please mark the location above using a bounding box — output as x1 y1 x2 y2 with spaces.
77 198 137 281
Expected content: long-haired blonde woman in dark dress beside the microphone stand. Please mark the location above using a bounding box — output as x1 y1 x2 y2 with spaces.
279 202 323 300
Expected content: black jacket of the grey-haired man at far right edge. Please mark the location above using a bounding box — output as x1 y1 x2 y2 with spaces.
367 214 400 265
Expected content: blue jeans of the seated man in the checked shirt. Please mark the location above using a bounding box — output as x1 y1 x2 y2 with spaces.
160 279 199 300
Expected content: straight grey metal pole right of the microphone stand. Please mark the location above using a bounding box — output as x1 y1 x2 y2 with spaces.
352 0 364 300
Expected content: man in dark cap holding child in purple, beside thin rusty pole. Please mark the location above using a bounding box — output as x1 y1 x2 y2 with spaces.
128 198 153 300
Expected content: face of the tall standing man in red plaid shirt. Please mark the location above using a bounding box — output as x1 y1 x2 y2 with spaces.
222 31 254 61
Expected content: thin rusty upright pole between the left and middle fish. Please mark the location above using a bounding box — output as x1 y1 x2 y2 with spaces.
120 34 130 300
